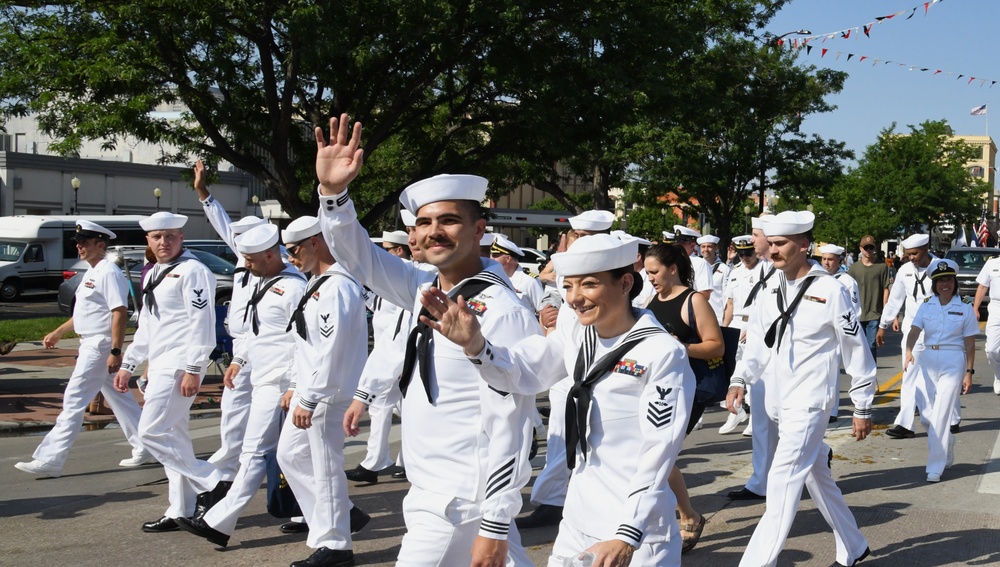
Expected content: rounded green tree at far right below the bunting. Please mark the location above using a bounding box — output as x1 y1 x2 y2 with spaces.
816 120 989 242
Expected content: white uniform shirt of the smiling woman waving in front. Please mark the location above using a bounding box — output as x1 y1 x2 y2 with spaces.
462 310 695 566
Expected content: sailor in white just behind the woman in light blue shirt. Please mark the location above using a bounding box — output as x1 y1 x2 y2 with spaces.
875 234 944 439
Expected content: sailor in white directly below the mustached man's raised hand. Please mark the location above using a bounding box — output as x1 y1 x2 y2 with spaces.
278 216 370 567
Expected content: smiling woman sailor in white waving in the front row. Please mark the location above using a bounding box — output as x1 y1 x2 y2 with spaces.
423 234 695 567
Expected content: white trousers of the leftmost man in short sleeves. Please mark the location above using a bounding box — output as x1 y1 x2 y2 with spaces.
32 335 144 469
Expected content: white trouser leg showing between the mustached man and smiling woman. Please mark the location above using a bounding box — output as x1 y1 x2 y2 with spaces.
531 378 573 506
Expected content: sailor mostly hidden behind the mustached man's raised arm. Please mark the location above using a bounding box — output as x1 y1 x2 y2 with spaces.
347 230 412 484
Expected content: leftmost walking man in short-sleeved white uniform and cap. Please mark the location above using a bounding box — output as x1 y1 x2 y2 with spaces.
14 220 150 477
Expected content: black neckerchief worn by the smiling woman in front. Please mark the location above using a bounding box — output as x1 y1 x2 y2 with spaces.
566 325 666 470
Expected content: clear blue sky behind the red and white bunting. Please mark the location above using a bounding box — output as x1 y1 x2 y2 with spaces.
767 0 1000 165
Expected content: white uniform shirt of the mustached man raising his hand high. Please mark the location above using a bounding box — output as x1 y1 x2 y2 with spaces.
318 192 541 558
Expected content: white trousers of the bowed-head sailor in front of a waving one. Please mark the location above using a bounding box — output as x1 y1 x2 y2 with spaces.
205 384 284 535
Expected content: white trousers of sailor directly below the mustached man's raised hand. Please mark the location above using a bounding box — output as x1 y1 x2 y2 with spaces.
278 396 353 549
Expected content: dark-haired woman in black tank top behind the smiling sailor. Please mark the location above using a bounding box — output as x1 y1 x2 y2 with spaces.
645 244 725 553
